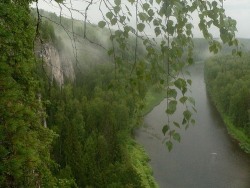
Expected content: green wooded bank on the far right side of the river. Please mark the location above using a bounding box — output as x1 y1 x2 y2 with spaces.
205 53 250 153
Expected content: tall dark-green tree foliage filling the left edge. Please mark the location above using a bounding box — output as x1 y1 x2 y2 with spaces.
0 1 56 187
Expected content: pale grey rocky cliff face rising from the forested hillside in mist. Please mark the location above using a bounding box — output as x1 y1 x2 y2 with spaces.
37 43 75 87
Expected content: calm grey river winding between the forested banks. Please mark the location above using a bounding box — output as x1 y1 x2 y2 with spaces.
136 64 250 188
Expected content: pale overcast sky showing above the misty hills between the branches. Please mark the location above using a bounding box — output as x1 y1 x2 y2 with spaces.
32 0 250 38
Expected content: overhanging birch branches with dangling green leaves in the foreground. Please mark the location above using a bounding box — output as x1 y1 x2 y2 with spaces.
37 0 240 150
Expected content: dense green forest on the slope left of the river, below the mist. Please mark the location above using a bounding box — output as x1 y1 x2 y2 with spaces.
39 16 160 187
